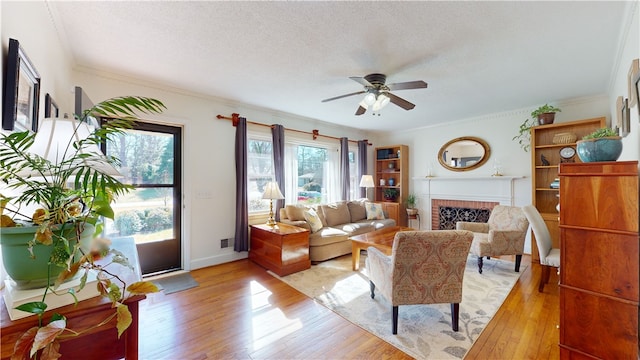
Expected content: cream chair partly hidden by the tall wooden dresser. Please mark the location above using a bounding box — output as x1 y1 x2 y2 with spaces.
522 205 560 292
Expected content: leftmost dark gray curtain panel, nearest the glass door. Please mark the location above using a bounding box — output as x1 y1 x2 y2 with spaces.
233 117 249 252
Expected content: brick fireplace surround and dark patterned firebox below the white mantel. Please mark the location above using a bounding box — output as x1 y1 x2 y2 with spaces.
431 199 500 230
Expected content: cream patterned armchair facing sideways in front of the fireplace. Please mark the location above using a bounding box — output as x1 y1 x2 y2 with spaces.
456 205 529 274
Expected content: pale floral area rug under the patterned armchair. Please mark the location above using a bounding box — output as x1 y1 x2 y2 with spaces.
271 253 526 359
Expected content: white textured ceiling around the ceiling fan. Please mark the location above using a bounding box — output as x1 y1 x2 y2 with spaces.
49 1 629 130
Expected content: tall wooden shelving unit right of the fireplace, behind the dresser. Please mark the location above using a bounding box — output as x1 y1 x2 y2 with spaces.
531 117 606 262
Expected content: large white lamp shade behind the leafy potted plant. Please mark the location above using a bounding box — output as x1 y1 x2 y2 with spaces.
23 118 121 176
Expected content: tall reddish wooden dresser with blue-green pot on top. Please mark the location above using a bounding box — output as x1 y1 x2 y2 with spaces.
559 161 640 359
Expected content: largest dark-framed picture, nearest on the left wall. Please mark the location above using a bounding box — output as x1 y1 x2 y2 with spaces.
2 39 40 131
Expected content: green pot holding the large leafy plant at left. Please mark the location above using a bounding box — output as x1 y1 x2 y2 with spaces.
0 224 95 290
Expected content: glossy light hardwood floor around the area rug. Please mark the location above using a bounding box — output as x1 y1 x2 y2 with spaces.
140 257 559 360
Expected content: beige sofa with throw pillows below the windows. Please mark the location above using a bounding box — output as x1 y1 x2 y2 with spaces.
280 200 396 262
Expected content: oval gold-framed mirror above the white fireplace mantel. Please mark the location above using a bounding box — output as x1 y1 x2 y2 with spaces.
438 136 491 171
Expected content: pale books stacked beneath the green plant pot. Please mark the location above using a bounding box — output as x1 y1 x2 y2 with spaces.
2 271 100 320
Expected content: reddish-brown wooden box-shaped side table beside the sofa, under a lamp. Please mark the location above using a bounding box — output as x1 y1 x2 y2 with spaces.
249 223 311 276
